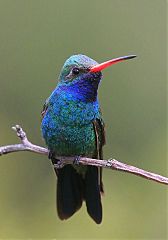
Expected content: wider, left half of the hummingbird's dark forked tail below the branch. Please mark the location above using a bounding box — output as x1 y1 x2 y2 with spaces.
57 165 84 220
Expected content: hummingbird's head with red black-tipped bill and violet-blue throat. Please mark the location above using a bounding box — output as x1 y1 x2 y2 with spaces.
59 54 136 101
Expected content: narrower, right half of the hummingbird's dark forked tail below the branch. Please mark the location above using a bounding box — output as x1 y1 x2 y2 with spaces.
85 166 103 224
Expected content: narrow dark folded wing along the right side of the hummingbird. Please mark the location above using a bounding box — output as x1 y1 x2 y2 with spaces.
93 117 106 193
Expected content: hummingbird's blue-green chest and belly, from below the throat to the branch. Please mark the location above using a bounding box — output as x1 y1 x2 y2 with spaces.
42 98 97 155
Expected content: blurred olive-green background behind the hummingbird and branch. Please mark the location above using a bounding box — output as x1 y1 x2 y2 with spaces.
0 0 167 239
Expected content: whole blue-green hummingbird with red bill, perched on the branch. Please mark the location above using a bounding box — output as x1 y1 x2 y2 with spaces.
41 54 136 224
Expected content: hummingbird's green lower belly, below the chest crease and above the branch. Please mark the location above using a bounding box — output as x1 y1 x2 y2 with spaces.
42 119 96 157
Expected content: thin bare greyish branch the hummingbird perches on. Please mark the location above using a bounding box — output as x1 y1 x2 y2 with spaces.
0 125 168 185
